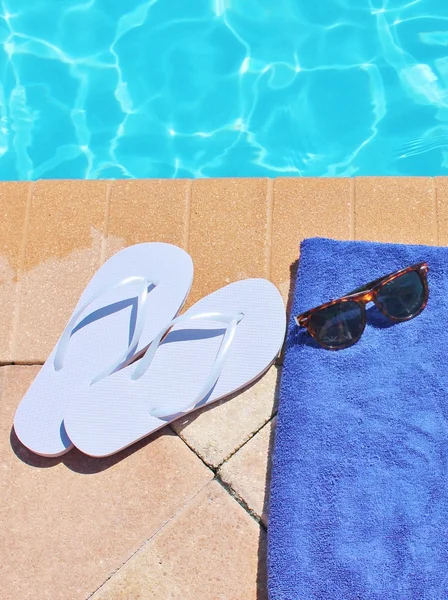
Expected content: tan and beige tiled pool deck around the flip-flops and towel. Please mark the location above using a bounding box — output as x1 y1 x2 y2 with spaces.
0 177 448 600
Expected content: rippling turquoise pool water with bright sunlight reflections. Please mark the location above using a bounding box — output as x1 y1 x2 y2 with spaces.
0 0 448 179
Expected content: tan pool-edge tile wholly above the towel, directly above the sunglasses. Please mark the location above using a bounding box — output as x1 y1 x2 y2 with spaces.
355 177 437 244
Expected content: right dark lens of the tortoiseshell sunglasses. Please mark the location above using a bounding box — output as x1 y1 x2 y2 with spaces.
376 271 426 320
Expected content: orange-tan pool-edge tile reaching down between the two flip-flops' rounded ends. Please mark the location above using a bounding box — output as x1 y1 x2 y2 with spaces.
187 179 270 306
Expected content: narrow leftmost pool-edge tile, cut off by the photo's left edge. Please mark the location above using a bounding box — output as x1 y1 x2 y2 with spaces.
0 181 31 362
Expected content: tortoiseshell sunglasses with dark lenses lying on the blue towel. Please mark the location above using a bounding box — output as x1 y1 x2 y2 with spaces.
295 263 429 350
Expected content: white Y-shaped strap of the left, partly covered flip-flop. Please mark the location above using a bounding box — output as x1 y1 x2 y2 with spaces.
53 276 152 383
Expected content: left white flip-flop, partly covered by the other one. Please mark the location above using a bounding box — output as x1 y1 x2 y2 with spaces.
14 243 193 456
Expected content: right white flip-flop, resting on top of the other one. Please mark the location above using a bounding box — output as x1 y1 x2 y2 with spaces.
64 279 286 457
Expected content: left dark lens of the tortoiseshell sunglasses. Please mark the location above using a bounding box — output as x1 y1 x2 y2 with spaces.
309 301 364 350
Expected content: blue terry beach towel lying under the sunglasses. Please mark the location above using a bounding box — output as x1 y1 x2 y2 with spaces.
268 238 448 600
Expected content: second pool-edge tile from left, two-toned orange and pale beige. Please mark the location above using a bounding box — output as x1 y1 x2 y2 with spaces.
13 181 110 362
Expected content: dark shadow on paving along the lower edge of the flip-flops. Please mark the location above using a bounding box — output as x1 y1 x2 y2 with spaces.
9 427 175 475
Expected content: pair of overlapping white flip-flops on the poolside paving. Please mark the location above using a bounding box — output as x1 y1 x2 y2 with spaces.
14 243 286 457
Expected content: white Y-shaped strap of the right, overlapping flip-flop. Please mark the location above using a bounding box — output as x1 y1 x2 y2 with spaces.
131 312 244 418
